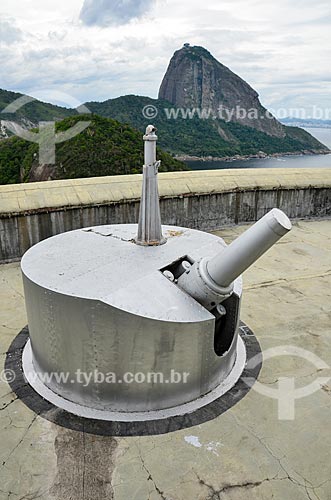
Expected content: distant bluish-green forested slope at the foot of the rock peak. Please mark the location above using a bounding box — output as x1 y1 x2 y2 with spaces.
87 95 327 157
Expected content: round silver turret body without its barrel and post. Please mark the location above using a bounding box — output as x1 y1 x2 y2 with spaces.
22 225 241 412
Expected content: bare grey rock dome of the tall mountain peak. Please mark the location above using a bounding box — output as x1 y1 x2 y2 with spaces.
159 43 285 137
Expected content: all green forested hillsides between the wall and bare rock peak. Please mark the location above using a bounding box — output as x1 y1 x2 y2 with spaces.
0 89 327 184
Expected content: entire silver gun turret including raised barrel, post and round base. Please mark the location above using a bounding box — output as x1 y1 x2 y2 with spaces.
21 126 291 421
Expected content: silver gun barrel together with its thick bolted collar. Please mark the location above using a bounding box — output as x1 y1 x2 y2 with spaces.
177 208 292 310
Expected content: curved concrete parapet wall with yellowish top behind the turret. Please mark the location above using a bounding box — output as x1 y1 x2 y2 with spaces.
0 168 331 262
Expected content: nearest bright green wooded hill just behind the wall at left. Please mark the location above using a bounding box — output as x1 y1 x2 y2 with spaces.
0 115 187 184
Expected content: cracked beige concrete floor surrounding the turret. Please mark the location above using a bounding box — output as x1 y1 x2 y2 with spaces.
0 220 331 500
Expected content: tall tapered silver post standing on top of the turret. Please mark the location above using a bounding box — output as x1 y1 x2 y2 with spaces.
136 125 166 246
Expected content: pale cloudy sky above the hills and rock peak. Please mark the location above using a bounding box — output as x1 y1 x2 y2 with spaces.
0 0 331 119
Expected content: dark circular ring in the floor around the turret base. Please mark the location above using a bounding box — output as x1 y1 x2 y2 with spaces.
5 323 262 436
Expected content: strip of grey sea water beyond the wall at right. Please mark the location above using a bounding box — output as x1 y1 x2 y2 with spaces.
185 128 331 170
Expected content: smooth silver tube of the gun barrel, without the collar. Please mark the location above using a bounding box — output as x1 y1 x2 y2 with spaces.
207 208 292 287
